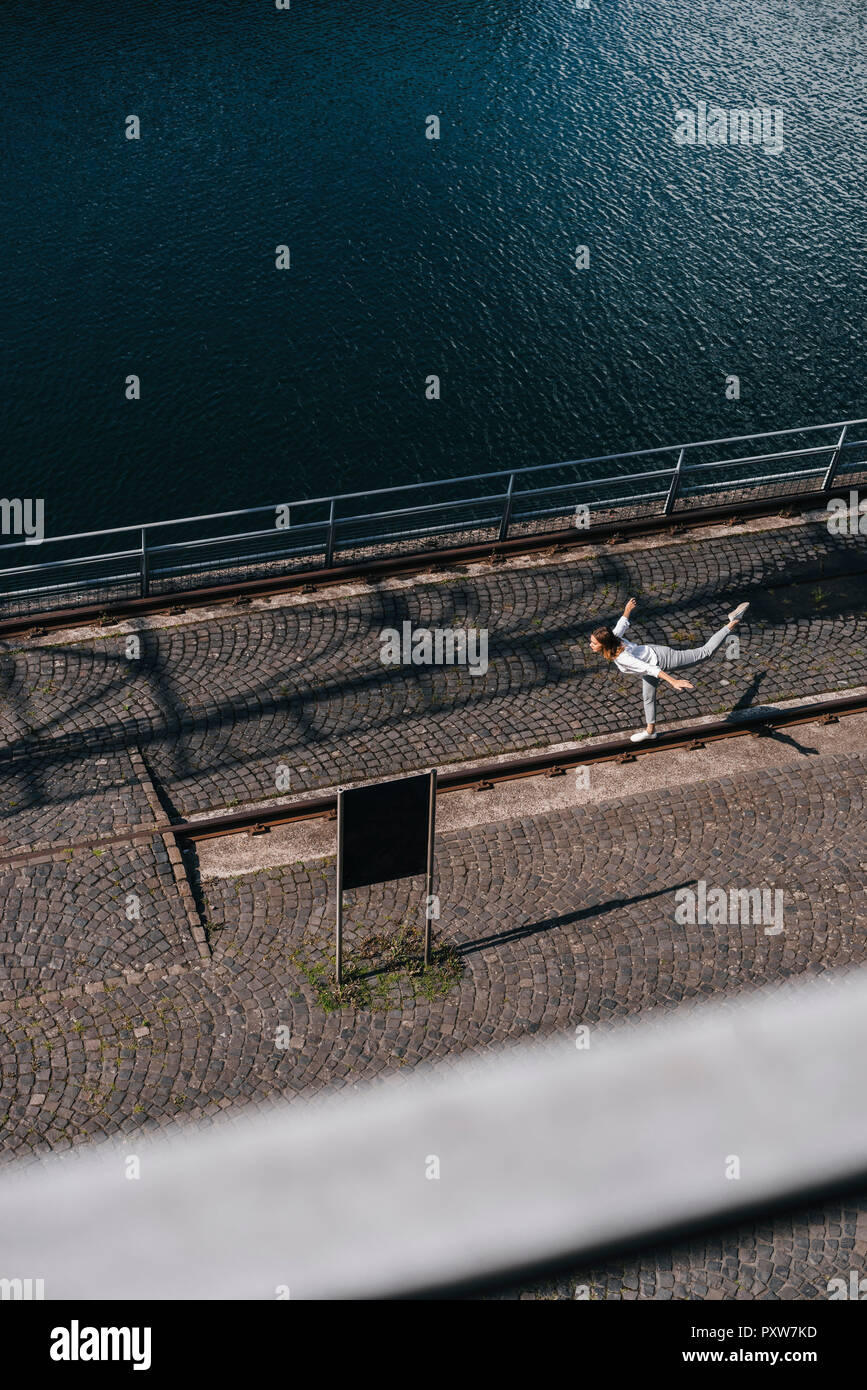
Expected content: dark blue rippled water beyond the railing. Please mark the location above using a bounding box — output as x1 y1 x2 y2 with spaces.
0 0 867 534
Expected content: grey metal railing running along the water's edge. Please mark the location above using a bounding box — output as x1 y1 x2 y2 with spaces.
0 420 867 617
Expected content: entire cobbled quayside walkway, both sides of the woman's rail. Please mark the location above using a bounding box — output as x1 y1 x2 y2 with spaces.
0 505 867 1298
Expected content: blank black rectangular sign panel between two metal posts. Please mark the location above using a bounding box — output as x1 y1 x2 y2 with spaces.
342 773 431 888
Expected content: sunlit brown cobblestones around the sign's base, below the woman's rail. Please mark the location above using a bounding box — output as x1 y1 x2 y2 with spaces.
0 753 867 1298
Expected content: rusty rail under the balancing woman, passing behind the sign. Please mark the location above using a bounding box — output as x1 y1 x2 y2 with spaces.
0 694 867 869
